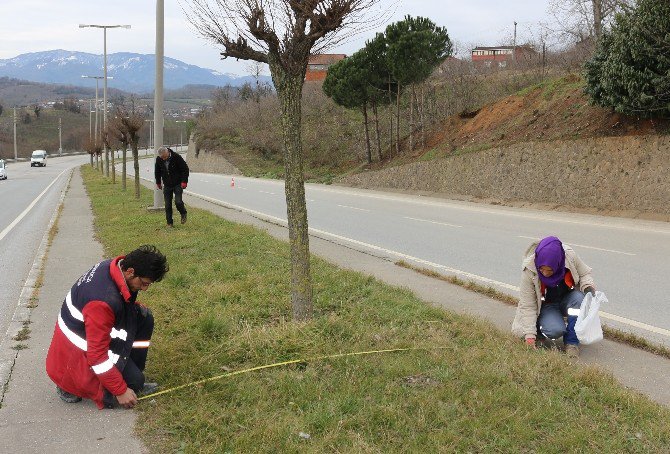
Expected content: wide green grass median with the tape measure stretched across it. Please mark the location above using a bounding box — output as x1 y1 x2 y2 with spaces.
83 167 670 453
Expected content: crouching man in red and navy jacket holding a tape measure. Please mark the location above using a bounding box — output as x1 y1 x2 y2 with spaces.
46 245 168 409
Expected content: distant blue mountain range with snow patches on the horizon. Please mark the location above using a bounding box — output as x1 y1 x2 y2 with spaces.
0 50 270 93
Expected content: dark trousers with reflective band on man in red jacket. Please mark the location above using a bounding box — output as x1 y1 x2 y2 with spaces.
103 306 154 408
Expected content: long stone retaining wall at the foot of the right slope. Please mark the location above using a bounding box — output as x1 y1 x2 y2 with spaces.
339 135 670 221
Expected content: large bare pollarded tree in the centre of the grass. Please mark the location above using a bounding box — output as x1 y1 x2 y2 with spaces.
186 0 380 320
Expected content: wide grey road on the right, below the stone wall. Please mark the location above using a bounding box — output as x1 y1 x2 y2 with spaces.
135 160 670 344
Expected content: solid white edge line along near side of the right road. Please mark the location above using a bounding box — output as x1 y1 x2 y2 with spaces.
145 178 670 337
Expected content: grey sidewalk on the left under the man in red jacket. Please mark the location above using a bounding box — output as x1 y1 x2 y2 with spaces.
0 169 145 454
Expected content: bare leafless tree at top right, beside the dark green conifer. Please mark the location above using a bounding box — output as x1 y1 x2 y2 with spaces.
546 0 635 42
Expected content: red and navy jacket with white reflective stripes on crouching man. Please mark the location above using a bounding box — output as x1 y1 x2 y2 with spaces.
46 257 143 408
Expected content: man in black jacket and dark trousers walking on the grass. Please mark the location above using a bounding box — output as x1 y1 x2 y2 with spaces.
154 147 188 227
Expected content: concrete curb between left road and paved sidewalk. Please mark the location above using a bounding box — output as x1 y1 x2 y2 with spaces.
0 171 73 405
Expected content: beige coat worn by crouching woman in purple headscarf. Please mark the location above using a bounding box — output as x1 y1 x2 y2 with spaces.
512 241 595 337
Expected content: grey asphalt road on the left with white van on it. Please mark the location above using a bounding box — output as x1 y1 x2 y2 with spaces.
0 156 88 335
